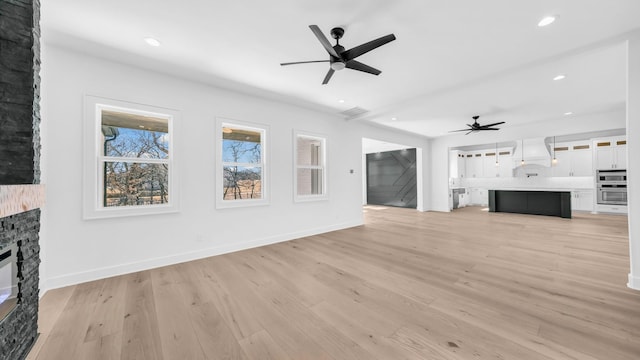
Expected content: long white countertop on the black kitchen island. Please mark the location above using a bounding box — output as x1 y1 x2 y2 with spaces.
456 176 595 190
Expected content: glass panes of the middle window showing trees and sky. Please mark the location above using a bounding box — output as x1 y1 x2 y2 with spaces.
222 125 263 200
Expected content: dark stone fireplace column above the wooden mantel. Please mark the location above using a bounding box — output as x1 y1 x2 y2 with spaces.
0 0 40 184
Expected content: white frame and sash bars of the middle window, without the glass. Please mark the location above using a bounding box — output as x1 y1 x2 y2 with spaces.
215 118 270 209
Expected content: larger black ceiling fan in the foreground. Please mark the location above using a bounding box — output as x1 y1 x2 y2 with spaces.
280 25 396 85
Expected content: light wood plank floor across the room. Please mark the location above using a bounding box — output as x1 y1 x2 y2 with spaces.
30 206 640 360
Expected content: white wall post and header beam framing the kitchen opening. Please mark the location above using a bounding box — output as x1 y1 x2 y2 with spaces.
428 111 625 211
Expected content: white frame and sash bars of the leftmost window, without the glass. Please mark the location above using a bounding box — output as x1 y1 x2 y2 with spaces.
82 95 180 220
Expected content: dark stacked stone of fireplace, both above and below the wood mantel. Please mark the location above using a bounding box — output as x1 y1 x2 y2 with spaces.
0 0 40 360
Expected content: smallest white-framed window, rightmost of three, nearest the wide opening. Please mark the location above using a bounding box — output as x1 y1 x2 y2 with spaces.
294 132 327 201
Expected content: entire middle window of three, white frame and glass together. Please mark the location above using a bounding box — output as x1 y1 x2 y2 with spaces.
216 120 268 208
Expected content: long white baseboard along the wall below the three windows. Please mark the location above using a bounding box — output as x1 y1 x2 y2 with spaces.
39 220 364 297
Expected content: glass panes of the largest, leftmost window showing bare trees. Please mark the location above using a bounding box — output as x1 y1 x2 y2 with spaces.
101 110 170 207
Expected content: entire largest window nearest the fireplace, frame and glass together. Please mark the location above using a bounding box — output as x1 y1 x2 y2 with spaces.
84 96 178 218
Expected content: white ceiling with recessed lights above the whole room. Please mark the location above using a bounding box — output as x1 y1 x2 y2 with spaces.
41 0 640 137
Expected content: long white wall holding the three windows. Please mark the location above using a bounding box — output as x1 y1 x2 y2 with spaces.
41 44 425 291
